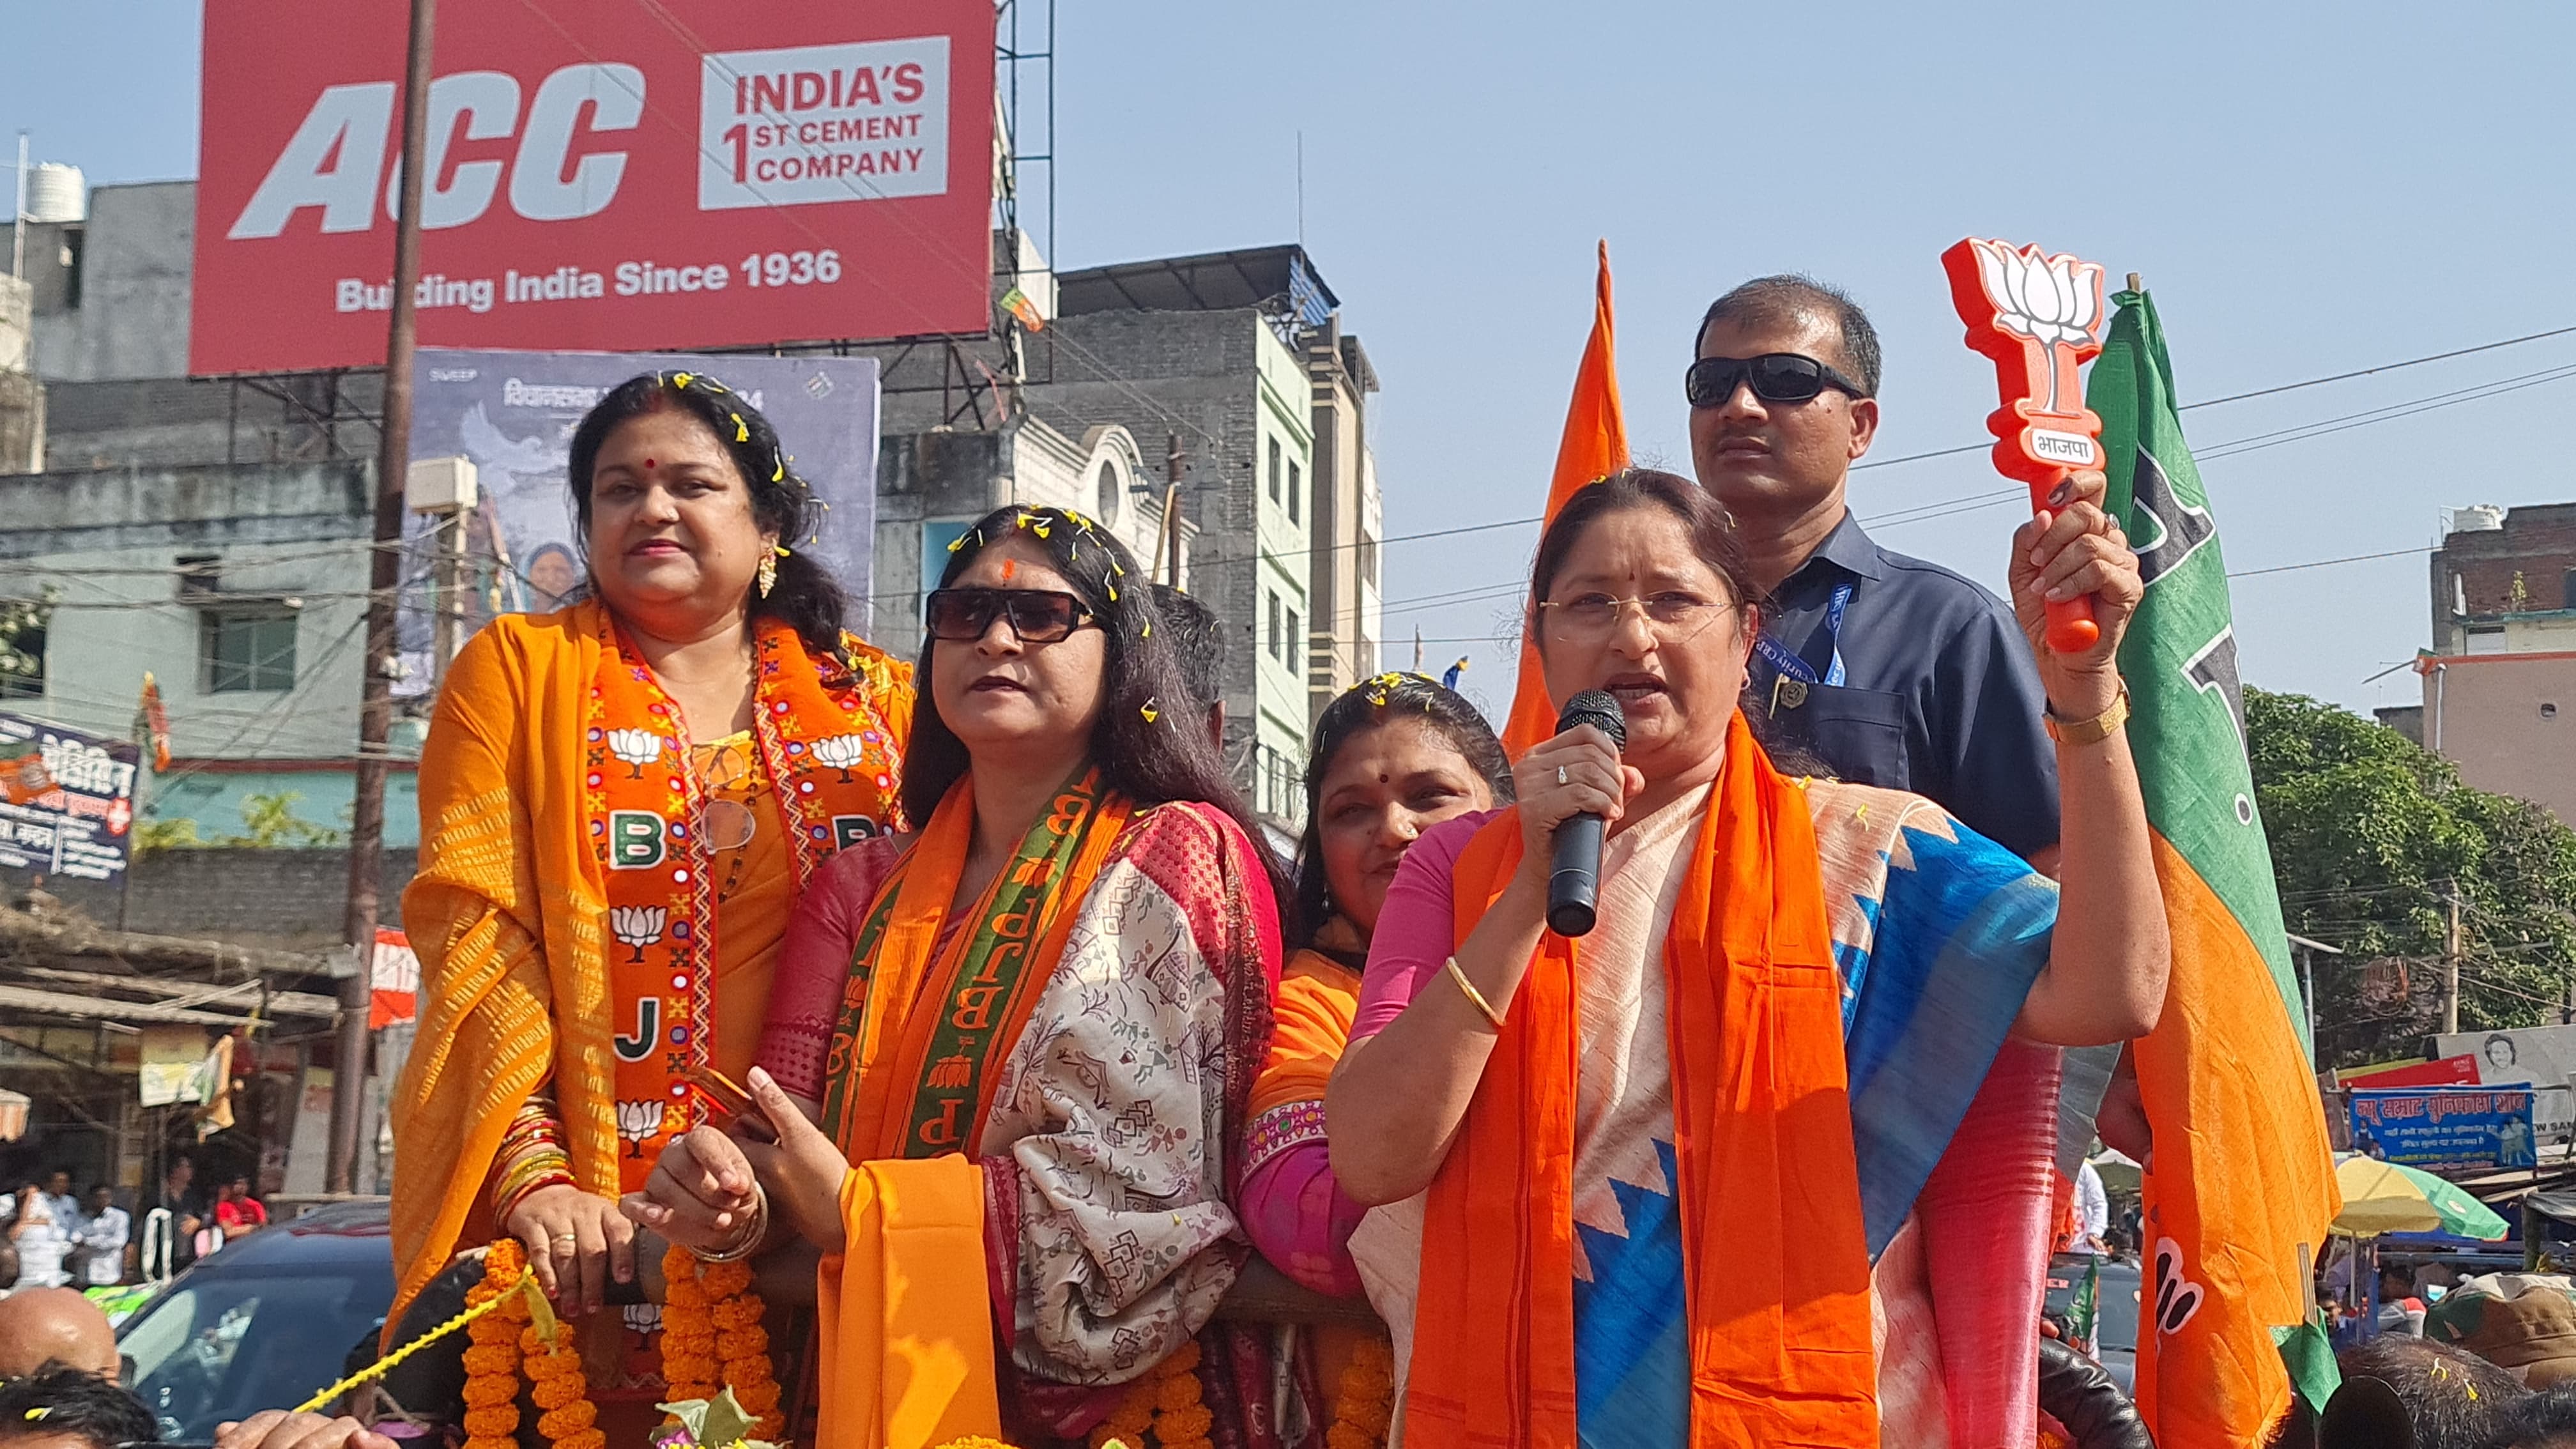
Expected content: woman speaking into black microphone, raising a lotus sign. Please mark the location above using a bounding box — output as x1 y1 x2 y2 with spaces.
1326 469 2169 1449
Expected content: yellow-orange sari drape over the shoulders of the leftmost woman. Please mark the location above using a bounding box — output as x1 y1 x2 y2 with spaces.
387 603 912 1328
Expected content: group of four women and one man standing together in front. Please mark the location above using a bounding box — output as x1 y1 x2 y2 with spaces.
0 279 2169 1449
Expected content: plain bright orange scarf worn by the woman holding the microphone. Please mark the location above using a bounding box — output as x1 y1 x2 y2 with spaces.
1404 714 1878 1449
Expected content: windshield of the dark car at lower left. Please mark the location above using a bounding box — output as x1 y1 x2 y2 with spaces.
116 1269 394 1441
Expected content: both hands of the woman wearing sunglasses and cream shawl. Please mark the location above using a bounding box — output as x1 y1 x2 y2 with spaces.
618 1068 850 1253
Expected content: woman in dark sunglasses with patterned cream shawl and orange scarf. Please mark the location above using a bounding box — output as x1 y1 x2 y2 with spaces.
631 508 1278 1449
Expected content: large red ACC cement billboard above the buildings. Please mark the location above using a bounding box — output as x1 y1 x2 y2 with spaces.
188 0 994 374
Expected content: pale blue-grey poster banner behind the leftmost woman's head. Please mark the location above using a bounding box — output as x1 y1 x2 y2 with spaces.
394 348 878 694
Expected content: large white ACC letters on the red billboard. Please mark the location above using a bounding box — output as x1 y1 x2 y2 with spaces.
227 62 644 240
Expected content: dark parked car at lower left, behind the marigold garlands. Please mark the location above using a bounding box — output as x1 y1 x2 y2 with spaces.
116 1199 394 1444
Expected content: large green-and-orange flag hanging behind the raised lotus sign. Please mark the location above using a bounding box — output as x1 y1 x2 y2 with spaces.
2087 291 2342 1449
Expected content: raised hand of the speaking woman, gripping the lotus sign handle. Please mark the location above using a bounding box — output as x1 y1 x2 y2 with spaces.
2012 469 2146 719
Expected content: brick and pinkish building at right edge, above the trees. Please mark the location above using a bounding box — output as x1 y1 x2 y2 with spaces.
2383 503 2576 822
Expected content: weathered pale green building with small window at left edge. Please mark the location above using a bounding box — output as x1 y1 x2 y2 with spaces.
0 459 420 846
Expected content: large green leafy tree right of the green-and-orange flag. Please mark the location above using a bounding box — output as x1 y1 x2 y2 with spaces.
2246 689 2576 1068
